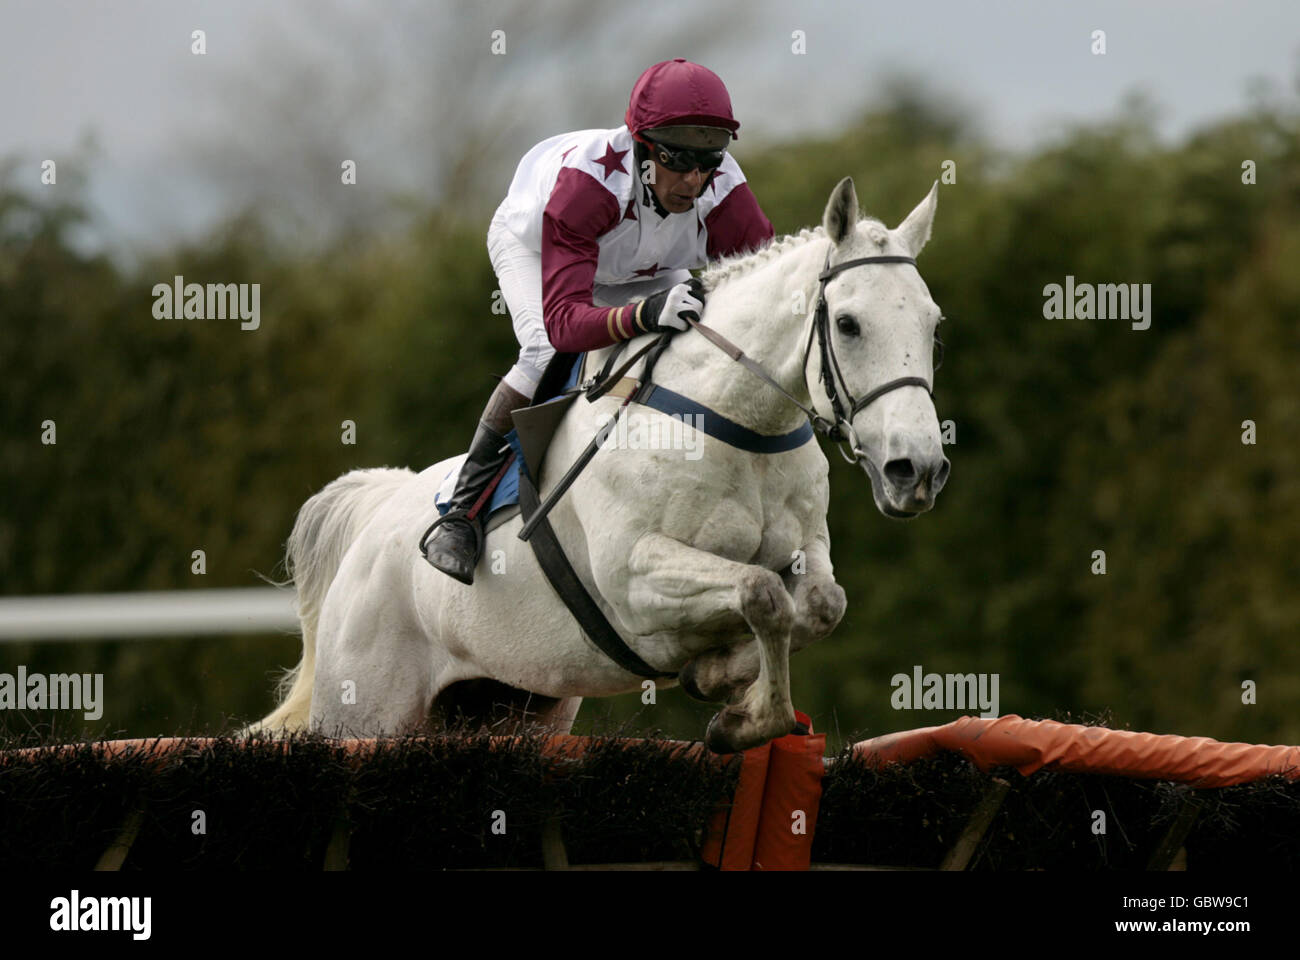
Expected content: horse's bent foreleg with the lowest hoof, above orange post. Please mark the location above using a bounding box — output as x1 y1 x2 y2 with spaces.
627 533 796 753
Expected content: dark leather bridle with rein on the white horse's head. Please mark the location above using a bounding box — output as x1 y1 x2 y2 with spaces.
688 243 944 463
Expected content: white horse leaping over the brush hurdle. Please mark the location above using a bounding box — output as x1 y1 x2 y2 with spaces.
246 178 948 752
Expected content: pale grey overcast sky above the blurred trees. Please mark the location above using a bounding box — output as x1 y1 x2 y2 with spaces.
0 0 1300 243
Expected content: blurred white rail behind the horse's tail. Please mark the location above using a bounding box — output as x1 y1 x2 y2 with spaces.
0 587 298 643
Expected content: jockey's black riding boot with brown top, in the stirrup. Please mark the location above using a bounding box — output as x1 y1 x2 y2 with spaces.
420 381 528 584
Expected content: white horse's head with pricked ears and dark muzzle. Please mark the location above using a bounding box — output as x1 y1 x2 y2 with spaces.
803 177 950 519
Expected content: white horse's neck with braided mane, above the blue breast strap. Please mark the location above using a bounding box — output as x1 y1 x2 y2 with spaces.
654 241 827 434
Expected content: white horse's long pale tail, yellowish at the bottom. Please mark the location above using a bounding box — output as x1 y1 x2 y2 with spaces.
237 467 415 736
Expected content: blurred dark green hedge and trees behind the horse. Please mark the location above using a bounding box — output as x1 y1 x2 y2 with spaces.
0 76 1300 743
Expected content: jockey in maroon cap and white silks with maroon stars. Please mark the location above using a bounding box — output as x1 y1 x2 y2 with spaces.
424 57 772 584
